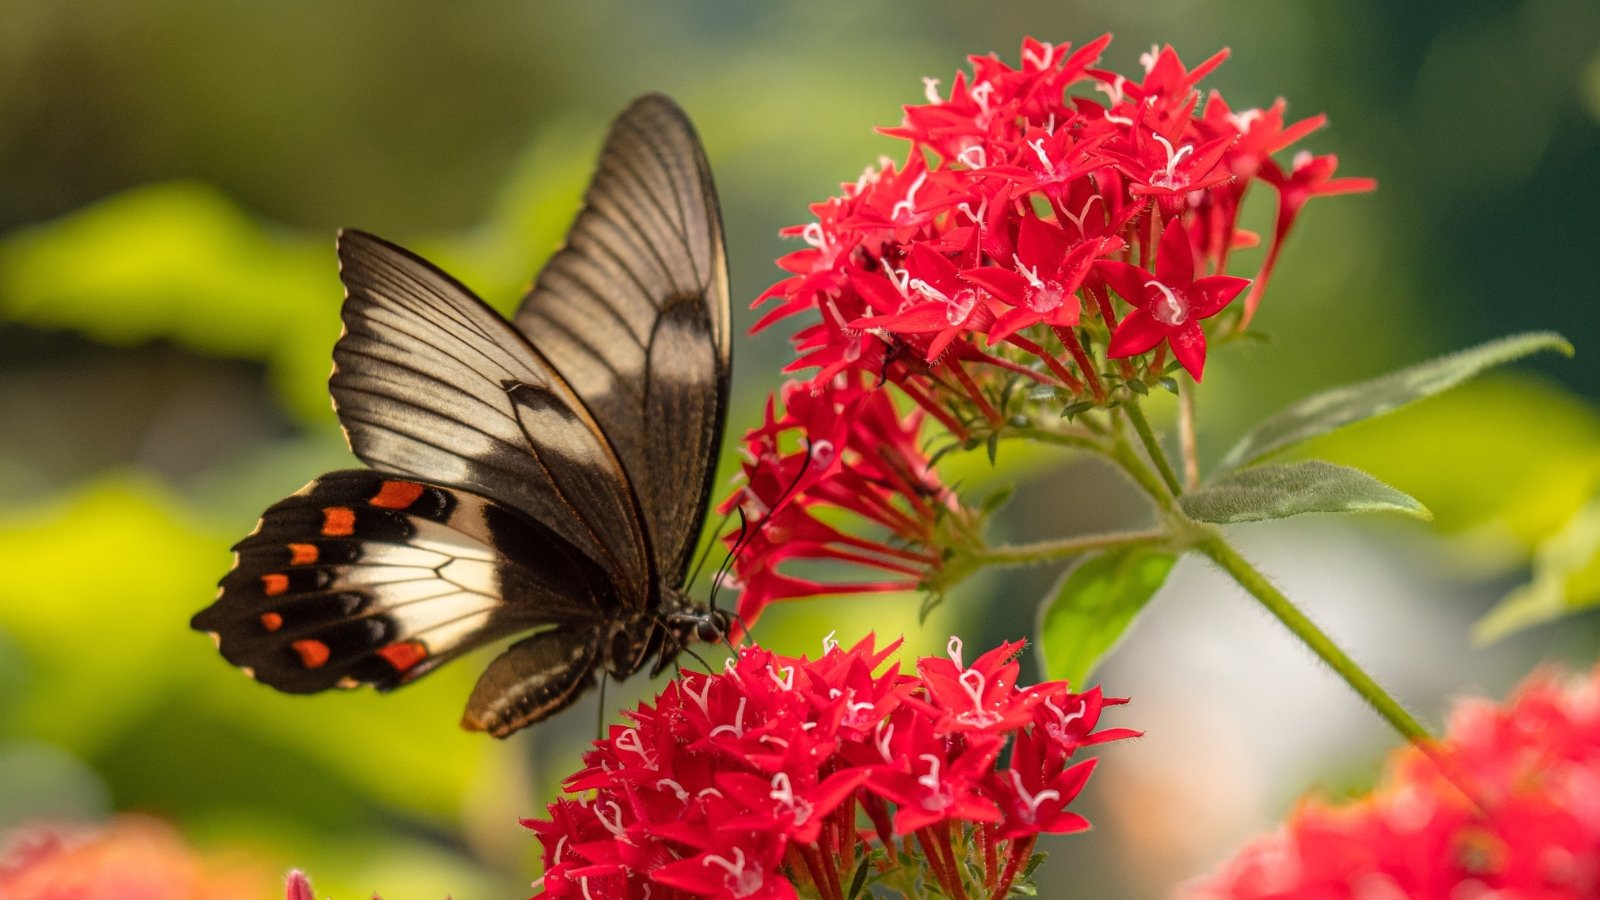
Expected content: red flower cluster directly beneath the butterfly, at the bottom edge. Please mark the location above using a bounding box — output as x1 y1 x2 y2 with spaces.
525 637 1138 900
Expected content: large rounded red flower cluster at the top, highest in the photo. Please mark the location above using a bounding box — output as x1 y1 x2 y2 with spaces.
757 35 1373 393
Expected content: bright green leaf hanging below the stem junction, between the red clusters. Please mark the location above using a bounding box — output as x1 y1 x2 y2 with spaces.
1038 546 1178 687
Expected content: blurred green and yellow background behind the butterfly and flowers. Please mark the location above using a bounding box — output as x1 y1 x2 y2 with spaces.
0 0 1600 900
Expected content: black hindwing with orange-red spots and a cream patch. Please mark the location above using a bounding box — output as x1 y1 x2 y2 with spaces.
190 471 619 693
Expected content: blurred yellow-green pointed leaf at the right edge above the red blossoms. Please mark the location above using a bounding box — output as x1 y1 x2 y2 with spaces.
1472 496 1600 644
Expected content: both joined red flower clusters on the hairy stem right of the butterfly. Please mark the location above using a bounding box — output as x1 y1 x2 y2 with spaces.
728 35 1373 618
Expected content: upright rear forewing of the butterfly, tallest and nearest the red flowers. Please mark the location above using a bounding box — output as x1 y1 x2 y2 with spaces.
515 94 730 585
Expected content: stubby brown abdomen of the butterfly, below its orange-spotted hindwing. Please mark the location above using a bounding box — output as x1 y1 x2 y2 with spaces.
461 625 600 738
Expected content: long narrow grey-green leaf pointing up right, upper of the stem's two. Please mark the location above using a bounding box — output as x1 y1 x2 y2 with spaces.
1218 331 1573 472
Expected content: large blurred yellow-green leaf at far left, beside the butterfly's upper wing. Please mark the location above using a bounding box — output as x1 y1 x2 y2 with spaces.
0 183 342 421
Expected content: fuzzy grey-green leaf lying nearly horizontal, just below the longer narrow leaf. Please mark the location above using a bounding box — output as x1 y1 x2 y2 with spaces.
1179 460 1432 525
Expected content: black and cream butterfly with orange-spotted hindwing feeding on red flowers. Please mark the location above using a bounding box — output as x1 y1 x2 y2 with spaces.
190 94 731 737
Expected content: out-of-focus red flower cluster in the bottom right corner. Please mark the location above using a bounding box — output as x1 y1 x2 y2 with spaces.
1186 668 1600 900
